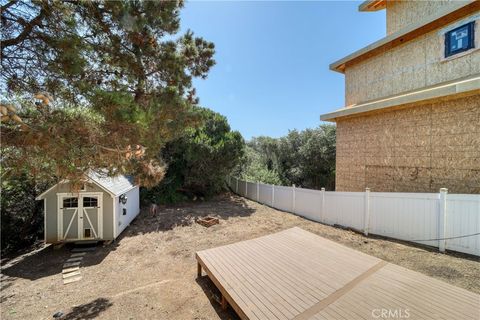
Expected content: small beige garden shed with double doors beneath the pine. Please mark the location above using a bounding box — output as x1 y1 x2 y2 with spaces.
36 172 140 243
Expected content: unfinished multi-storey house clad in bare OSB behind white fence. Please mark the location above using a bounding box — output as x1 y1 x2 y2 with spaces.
320 0 480 193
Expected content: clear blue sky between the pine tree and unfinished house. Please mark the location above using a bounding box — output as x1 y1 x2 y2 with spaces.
181 1 385 140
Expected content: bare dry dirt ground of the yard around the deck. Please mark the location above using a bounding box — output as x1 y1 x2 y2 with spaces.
1 194 480 320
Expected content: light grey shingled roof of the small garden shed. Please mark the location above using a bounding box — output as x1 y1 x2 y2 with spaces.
35 171 136 200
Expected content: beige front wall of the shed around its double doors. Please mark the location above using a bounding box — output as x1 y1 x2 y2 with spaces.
43 183 114 243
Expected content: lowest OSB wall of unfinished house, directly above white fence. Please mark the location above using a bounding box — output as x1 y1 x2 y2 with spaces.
336 94 480 194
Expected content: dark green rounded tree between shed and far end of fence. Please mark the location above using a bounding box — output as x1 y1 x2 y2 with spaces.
142 108 245 203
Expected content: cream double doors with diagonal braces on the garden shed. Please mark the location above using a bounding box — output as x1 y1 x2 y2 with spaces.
58 193 103 241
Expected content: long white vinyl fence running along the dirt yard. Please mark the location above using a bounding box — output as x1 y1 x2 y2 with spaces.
227 177 480 256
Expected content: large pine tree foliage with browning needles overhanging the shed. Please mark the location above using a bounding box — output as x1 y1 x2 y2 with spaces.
0 0 214 185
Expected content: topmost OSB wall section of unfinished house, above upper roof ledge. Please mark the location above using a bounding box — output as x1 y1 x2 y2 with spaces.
386 0 459 34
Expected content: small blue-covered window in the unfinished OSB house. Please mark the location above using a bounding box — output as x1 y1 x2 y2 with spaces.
445 21 475 58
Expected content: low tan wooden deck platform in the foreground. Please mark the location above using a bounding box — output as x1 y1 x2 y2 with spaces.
196 228 480 320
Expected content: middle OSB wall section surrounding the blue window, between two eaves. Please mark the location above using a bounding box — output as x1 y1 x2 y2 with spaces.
345 12 480 106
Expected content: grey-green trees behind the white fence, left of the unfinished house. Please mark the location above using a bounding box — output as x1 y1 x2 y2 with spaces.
233 125 335 190
